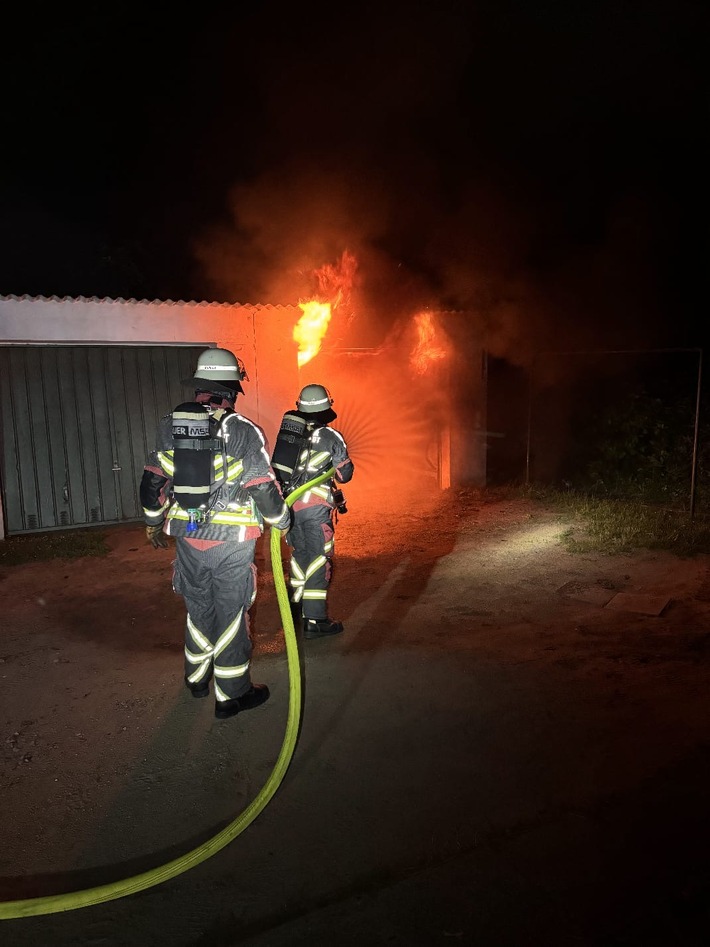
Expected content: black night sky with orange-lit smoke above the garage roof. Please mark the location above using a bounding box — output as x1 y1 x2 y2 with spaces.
0 0 710 356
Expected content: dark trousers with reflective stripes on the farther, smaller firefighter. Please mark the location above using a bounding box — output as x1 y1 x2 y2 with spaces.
286 505 334 618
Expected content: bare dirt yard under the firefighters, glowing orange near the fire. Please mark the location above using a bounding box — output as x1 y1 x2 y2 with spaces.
0 490 710 947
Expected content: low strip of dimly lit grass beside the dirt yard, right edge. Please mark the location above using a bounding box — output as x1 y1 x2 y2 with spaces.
531 491 710 557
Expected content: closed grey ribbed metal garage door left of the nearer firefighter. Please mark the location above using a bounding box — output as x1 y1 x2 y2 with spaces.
0 345 204 535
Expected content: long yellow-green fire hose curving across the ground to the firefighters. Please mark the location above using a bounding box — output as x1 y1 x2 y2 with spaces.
0 467 335 920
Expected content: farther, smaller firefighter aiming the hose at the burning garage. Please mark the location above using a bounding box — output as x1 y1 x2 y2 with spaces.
272 385 354 638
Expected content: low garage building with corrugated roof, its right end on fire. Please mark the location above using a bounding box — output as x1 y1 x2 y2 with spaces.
0 288 486 536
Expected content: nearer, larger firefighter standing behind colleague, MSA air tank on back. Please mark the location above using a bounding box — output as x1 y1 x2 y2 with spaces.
140 348 291 718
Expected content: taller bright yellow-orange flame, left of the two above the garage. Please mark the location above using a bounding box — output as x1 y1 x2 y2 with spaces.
293 250 357 368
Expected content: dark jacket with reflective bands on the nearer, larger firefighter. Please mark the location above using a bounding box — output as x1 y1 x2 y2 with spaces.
140 411 290 542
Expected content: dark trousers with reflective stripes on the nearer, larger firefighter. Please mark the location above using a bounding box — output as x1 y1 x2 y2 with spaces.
173 537 256 700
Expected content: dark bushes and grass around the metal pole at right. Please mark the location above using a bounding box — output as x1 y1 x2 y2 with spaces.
525 366 710 556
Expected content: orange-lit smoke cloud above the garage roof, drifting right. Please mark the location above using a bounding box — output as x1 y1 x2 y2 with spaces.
195 148 672 365
